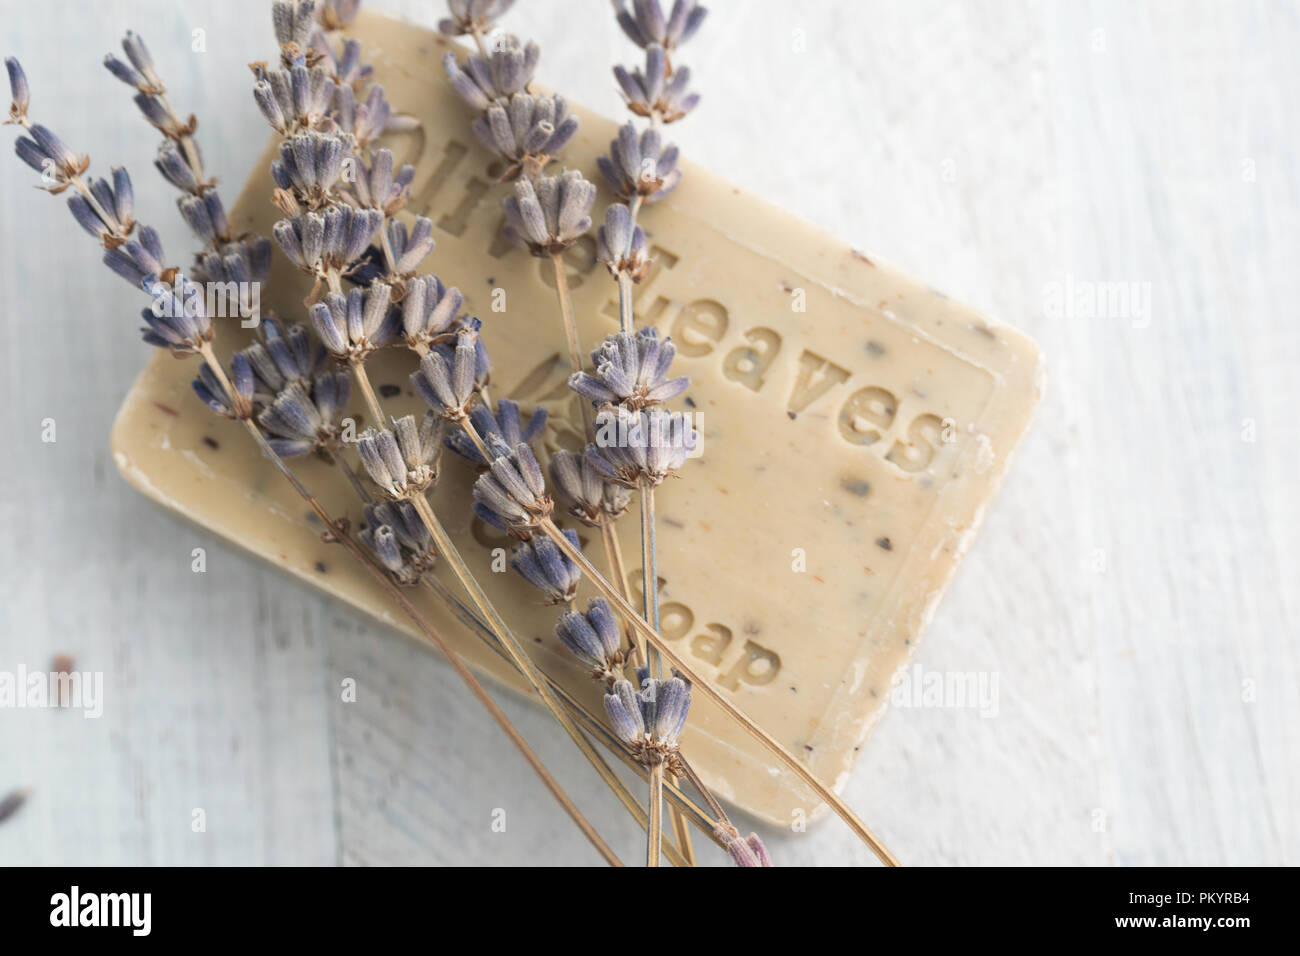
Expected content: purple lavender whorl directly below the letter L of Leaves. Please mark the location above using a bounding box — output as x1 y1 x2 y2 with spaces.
568 325 690 411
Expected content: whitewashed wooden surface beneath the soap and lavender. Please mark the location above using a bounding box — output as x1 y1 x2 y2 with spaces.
0 0 1300 864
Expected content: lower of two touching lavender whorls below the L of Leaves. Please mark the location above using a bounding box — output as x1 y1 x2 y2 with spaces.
586 408 699 488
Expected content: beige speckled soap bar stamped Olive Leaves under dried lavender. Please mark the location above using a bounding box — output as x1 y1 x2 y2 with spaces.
113 13 1043 825
